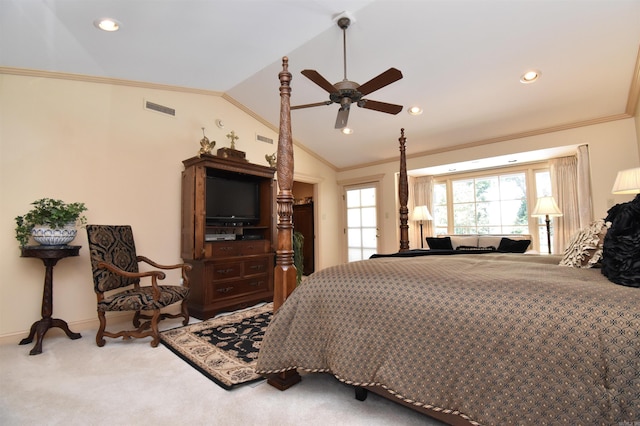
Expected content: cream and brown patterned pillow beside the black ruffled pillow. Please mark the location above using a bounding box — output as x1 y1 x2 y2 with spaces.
559 219 607 268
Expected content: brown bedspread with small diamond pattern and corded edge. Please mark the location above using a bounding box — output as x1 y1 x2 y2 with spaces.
257 254 640 425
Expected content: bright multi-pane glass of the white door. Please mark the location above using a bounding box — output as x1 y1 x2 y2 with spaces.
344 184 379 262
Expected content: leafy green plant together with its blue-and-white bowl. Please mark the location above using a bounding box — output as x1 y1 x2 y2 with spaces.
15 198 87 246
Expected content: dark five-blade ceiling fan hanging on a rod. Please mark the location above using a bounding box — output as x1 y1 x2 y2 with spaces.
291 17 402 129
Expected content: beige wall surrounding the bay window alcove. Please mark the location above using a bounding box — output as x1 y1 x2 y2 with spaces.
338 118 640 253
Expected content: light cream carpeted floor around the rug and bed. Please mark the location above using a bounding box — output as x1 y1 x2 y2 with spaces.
0 304 441 426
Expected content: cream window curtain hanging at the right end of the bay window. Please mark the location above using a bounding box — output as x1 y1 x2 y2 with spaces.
549 145 592 254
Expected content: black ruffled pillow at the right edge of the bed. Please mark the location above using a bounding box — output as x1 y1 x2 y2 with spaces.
602 195 640 288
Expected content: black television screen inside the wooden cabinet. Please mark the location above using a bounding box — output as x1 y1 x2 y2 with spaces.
205 176 260 226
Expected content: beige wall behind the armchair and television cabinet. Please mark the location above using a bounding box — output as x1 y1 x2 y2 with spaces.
0 74 339 340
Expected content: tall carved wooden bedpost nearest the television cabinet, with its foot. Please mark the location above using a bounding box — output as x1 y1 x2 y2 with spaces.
267 56 301 390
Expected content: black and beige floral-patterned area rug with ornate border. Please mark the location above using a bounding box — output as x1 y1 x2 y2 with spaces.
160 303 273 390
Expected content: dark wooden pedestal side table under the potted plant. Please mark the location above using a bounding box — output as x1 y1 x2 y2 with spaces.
20 246 82 355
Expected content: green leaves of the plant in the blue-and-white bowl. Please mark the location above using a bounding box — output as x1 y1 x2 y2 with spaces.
16 198 87 246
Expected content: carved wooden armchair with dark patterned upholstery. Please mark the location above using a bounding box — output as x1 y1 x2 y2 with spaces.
87 225 191 348
